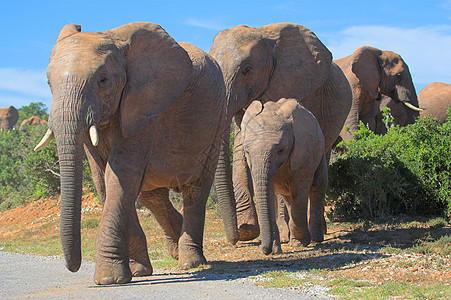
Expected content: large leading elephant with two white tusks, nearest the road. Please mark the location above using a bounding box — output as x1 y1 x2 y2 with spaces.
35 22 226 285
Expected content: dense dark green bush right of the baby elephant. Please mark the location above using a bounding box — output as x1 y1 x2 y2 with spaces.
327 109 451 220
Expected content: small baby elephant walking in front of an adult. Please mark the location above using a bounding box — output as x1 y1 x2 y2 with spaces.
242 98 327 255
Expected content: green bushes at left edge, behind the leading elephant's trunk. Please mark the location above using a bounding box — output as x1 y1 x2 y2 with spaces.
0 103 93 211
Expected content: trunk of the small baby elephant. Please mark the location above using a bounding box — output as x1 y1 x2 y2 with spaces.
251 164 276 255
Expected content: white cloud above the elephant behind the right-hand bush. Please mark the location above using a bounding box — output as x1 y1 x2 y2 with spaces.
324 26 451 92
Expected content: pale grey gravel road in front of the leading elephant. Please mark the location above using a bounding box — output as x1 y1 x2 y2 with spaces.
0 251 332 299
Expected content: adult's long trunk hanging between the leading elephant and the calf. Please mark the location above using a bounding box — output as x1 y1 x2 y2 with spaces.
215 126 238 245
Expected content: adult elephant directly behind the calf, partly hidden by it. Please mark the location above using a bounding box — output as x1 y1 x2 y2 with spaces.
209 23 352 244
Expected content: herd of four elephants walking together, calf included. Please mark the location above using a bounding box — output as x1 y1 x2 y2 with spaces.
27 23 451 284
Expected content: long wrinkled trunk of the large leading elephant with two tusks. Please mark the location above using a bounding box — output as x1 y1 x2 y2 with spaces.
48 86 92 272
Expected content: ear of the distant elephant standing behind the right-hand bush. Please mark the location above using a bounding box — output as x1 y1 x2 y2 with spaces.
351 46 382 99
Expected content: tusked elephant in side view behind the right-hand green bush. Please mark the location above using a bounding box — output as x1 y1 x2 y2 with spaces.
334 46 421 141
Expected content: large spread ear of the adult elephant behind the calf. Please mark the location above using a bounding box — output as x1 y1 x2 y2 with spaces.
261 23 332 100
